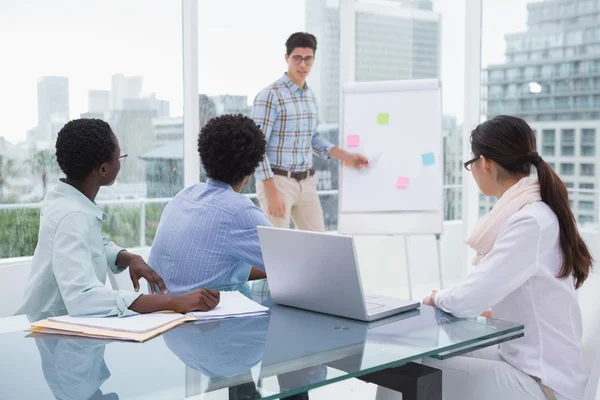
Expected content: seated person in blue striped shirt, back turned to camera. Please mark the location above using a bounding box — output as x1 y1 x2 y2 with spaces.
149 115 271 294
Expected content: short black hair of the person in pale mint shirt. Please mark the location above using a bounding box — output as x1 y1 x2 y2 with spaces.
56 118 117 181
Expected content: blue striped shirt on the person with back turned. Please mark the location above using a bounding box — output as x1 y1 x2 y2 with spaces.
148 179 271 294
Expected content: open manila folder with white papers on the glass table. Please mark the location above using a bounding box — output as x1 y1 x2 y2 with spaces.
29 292 268 342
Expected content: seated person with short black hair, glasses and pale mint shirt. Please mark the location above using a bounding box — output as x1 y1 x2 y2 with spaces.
17 119 219 317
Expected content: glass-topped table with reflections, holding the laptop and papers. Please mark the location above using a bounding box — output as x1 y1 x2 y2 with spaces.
0 285 524 400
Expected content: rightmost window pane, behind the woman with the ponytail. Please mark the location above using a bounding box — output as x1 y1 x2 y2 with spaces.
481 0 600 230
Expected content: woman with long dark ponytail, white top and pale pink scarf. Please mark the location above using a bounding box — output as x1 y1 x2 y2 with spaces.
408 116 592 400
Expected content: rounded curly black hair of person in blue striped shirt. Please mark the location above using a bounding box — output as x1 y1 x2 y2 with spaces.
198 114 267 185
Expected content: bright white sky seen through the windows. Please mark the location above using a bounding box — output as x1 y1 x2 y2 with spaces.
0 0 530 143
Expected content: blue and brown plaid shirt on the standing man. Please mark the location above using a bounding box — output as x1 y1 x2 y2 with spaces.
252 74 334 180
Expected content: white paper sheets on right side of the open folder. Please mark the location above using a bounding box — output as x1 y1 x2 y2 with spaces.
187 292 269 321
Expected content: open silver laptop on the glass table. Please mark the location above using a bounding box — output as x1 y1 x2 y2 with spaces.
257 226 420 321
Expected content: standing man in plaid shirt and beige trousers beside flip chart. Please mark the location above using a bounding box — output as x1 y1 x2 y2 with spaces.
252 32 368 232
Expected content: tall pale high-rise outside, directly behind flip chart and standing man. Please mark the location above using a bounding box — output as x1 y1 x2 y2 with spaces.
306 0 441 123
